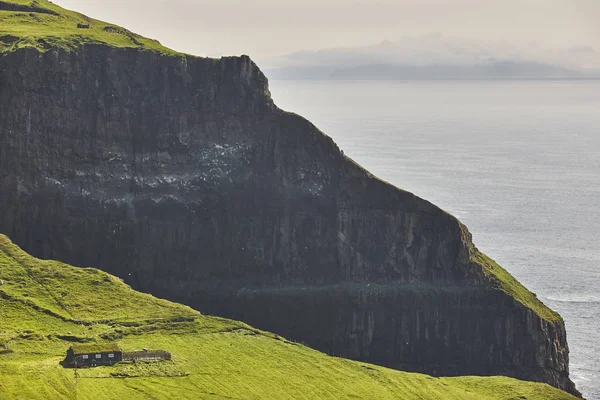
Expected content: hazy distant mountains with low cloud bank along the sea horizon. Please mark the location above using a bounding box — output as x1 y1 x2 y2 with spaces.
265 34 600 80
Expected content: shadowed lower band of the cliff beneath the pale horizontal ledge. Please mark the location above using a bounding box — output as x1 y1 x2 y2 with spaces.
192 283 580 396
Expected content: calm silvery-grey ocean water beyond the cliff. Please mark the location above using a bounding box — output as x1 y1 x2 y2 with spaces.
271 77 600 400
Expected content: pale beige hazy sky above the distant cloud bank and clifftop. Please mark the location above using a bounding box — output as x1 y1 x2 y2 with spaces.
55 0 600 59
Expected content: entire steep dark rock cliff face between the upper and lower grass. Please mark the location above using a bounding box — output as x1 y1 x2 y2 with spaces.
0 45 576 393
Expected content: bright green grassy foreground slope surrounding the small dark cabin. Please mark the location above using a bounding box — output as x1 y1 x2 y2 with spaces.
0 235 574 400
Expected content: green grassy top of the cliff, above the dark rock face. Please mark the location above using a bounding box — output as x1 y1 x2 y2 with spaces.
0 0 175 54
